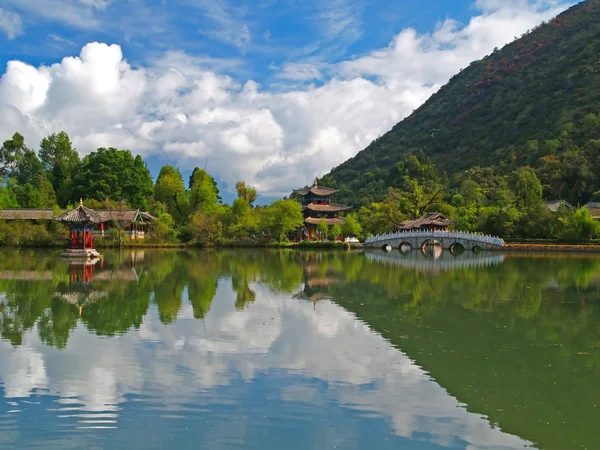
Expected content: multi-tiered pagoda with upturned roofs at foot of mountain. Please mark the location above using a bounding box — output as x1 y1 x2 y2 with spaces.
294 179 350 238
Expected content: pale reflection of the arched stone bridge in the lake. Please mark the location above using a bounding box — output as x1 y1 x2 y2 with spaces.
365 247 504 272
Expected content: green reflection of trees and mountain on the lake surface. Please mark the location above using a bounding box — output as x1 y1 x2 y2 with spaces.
0 250 600 448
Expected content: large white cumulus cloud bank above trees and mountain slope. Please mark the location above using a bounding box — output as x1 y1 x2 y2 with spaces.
0 0 567 197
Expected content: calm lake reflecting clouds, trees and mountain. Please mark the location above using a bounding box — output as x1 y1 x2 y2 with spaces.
0 250 600 450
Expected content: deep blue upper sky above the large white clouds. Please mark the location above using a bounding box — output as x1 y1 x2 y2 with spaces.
0 0 477 82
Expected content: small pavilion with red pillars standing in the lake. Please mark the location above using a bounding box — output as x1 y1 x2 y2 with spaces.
58 200 103 258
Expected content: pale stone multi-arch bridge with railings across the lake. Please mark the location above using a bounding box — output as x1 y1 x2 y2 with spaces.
365 230 504 252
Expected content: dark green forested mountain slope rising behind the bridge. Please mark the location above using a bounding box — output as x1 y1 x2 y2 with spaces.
321 0 600 206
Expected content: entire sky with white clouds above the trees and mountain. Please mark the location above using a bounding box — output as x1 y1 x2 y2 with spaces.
0 0 573 199
